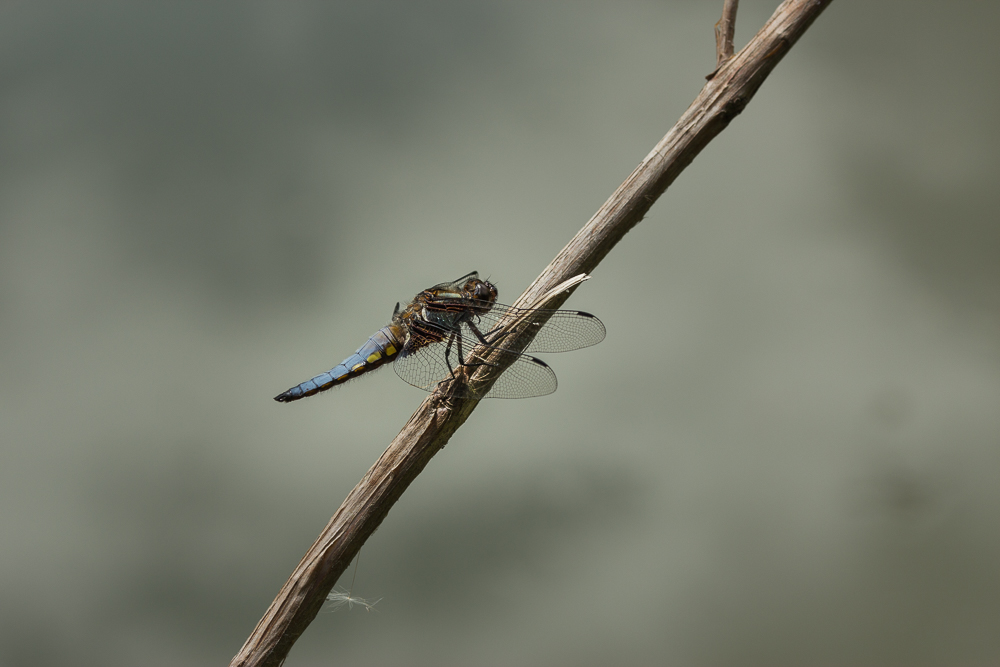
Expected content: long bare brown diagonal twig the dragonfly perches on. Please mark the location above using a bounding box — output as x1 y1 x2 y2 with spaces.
231 0 832 667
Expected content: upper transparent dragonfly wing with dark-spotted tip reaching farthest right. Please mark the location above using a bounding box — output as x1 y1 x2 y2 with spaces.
458 303 606 352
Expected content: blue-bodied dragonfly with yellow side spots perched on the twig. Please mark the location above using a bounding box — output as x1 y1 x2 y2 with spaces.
274 271 605 403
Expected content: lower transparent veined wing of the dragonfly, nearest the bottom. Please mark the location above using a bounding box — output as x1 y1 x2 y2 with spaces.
393 333 558 398
